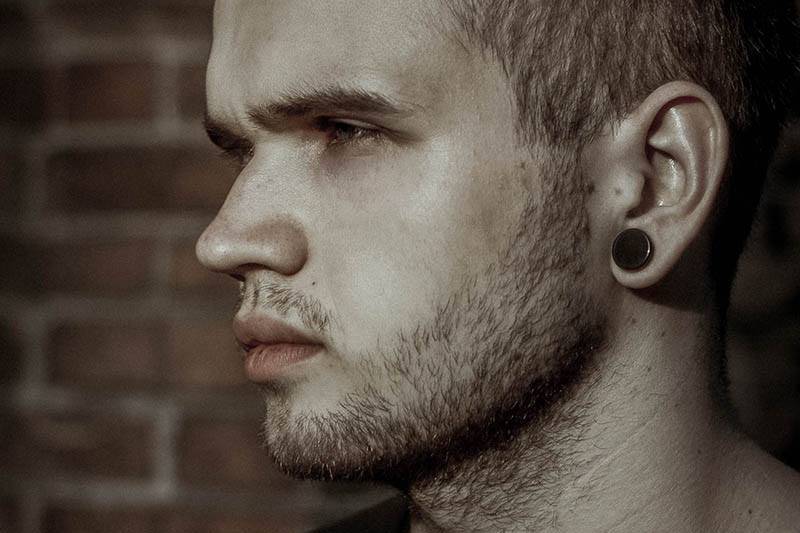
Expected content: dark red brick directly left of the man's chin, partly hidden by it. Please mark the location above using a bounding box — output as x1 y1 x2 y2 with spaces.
178 418 296 490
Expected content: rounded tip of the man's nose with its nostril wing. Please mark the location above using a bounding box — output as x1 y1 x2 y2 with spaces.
195 214 308 276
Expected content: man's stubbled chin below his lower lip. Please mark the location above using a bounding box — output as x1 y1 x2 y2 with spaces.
261 372 428 484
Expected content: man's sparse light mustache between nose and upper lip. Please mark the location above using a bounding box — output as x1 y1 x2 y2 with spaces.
236 280 332 335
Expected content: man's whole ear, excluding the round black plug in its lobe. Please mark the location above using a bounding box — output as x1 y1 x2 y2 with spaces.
603 82 729 289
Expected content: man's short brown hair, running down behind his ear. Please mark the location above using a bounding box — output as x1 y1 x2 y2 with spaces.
444 0 800 312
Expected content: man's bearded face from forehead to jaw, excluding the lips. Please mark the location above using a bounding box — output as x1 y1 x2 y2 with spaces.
198 0 600 480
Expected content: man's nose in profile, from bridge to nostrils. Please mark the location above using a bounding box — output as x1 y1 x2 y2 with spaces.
195 176 308 279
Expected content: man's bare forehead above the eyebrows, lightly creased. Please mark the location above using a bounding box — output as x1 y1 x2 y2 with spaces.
207 0 458 119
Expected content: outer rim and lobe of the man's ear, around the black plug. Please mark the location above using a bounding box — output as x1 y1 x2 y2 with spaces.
608 81 730 289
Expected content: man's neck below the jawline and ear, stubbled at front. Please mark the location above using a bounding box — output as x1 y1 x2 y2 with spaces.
408 301 732 533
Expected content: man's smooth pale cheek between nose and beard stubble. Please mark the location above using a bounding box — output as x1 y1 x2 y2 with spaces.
323 156 459 349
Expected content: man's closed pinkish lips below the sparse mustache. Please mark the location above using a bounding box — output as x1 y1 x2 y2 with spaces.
233 313 324 383
